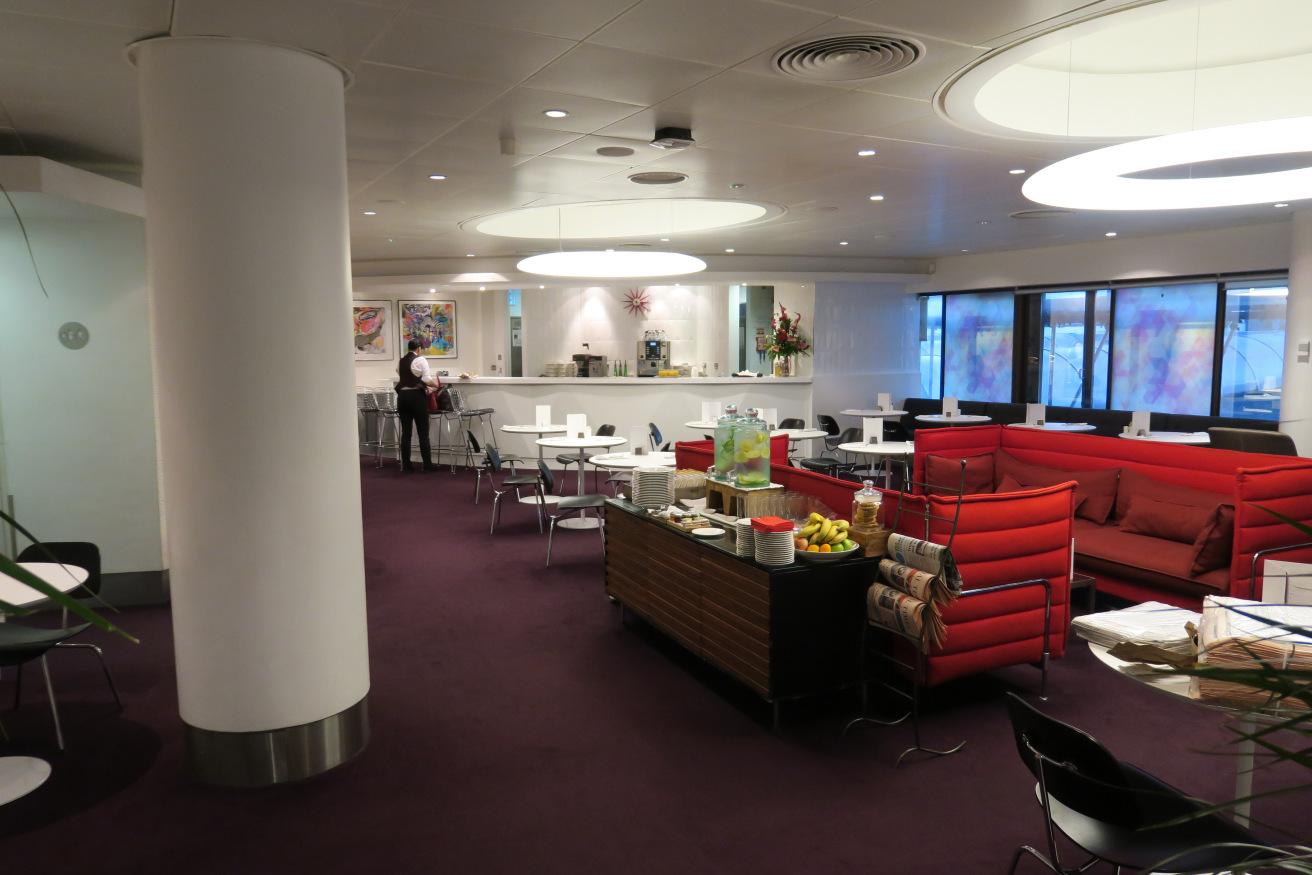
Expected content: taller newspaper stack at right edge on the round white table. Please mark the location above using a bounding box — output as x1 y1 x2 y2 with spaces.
1193 596 1312 708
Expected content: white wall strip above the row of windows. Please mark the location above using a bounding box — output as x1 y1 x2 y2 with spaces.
923 219 1290 293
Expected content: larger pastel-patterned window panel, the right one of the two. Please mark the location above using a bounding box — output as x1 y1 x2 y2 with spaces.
1111 282 1216 415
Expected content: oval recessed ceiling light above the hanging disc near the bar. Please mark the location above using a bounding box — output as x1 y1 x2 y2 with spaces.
461 198 783 240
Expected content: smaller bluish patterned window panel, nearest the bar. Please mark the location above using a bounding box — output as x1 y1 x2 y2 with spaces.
943 291 1015 401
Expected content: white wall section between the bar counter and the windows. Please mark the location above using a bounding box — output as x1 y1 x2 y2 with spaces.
812 282 920 417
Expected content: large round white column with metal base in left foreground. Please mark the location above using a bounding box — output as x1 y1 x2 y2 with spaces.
130 38 369 784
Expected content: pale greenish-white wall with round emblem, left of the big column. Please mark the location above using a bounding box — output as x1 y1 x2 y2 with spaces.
0 213 164 573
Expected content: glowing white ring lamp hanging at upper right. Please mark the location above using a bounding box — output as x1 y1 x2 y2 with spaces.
1021 118 1312 210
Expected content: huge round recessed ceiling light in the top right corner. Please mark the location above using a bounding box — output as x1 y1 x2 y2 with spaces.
935 0 1312 140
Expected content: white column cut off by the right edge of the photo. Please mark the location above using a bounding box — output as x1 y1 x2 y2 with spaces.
1281 209 1312 455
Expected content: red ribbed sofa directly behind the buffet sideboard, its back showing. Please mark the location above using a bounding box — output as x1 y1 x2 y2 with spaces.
674 441 1075 685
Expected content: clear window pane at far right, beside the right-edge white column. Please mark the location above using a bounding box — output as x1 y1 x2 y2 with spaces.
1219 279 1290 420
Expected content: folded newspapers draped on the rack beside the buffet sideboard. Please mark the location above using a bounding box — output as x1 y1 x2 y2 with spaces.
866 534 962 651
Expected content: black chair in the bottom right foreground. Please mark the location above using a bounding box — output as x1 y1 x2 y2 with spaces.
1006 693 1277 875
